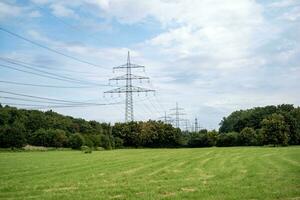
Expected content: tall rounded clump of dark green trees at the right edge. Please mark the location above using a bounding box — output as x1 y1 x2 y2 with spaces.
219 104 300 146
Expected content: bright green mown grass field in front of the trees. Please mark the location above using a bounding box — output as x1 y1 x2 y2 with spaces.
0 147 300 200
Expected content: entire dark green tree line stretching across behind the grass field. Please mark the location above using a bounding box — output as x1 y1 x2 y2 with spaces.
0 104 300 149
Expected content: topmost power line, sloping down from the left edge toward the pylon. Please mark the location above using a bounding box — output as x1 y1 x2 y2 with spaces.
0 26 105 69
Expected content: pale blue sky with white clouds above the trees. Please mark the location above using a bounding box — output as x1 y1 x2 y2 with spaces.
0 0 300 129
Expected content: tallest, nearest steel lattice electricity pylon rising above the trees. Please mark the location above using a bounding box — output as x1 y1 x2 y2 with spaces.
104 51 154 122
